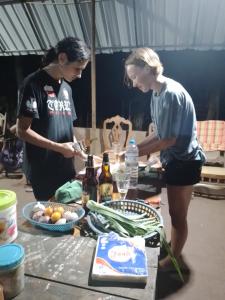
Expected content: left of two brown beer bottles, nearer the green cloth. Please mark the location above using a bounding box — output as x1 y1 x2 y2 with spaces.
82 155 98 214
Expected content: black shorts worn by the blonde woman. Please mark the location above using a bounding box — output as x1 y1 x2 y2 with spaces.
163 160 202 186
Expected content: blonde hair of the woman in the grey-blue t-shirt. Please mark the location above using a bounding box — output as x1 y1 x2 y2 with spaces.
125 48 163 85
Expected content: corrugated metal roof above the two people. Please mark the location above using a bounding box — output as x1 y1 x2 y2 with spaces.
0 0 225 56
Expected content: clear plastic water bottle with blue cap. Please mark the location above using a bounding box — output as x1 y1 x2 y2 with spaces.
125 139 138 188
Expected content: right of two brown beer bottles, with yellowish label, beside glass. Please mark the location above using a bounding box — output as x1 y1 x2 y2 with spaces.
98 153 113 203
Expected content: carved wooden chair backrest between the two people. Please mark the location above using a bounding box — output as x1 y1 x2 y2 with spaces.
103 115 132 150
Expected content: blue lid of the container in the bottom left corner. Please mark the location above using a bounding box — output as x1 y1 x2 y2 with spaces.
0 244 24 270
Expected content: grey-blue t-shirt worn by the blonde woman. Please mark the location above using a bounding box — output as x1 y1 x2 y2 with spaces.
151 77 205 165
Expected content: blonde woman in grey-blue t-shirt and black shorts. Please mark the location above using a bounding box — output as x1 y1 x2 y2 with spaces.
125 48 205 269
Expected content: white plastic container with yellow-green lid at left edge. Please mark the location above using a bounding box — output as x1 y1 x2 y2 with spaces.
0 190 18 245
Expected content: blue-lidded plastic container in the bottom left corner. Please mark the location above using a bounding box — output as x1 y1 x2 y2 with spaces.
0 244 25 299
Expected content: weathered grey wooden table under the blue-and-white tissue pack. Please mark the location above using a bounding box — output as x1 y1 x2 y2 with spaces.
15 184 162 300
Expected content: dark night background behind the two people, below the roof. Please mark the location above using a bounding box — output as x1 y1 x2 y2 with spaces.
0 50 225 130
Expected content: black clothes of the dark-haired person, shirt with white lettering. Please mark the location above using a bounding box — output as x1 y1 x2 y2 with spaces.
18 70 76 200
